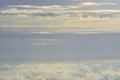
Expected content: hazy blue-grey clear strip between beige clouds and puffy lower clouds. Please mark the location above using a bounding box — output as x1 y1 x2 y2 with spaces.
0 31 120 61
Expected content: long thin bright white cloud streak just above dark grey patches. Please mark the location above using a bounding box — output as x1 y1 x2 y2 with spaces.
0 6 120 16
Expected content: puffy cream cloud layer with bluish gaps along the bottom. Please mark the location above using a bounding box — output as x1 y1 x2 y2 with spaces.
0 61 120 80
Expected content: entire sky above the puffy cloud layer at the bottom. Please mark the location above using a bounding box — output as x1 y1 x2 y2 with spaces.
0 0 120 61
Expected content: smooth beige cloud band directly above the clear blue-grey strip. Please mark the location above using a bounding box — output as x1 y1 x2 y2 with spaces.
0 16 120 34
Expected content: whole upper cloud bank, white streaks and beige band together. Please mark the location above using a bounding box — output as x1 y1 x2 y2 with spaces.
0 0 120 34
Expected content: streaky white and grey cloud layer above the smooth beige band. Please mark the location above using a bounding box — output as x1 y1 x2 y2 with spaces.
0 2 120 18
